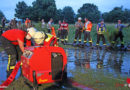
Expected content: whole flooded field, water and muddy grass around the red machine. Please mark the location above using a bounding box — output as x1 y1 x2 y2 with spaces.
0 48 130 90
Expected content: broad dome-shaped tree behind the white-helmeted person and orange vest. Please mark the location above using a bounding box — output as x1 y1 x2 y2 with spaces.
77 3 101 22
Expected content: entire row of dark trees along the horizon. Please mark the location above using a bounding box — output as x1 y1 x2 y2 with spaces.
0 0 130 24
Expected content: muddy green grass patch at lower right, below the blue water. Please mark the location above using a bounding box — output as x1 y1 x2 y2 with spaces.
72 69 129 90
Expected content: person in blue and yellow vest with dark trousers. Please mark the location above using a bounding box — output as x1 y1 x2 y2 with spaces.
96 19 106 46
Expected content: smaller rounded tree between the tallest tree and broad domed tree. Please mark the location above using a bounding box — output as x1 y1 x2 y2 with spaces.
63 6 75 23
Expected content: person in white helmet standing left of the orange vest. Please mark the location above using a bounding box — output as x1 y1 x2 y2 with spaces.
73 17 84 44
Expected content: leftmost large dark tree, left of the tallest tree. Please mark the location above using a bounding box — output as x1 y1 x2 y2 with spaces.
15 1 29 20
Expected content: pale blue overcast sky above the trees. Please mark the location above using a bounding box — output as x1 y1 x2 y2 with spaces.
0 0 130 19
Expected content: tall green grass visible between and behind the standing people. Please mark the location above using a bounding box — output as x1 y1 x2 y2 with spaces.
35 23 130 45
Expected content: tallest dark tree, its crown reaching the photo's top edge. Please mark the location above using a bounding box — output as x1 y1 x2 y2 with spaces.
32 0 57 21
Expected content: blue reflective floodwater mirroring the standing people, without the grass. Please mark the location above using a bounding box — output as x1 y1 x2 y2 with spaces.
0 48 130 84
